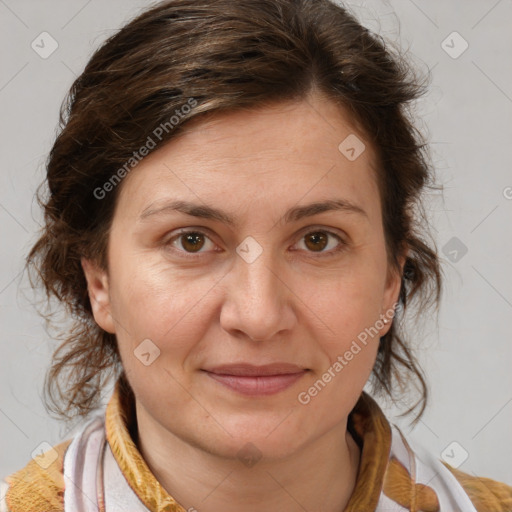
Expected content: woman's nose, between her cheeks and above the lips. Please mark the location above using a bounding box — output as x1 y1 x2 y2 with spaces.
220 245 296 341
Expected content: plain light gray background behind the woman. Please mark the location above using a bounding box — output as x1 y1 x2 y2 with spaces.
0 0 512 485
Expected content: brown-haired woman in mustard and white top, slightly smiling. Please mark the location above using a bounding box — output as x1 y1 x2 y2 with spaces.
3 0 512 512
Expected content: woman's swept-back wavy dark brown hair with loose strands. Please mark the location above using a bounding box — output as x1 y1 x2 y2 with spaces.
27 0 441 421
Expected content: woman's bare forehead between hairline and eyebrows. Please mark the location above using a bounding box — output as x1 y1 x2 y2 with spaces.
114 97 380 225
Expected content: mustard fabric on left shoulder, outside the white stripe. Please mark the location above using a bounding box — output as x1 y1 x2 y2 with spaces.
0 439 72 512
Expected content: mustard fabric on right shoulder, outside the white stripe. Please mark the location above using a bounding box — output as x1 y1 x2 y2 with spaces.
441 461 512 512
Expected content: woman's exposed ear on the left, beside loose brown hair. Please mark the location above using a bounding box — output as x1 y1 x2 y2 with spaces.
81 258 115 334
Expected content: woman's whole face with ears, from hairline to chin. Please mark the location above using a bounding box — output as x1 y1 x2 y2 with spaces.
83 91 400 457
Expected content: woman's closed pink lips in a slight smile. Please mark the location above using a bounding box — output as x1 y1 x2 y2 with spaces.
203 363 309 396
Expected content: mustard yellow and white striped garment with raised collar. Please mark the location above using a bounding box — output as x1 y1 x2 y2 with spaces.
0 382 512 512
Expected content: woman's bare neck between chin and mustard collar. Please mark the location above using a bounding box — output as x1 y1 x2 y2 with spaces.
137 406 360 512
